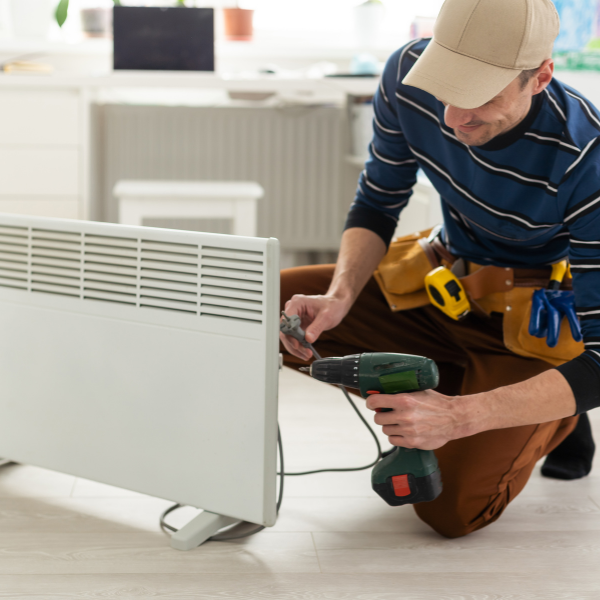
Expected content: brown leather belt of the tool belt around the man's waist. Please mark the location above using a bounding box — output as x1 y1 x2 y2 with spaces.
421 237 572 300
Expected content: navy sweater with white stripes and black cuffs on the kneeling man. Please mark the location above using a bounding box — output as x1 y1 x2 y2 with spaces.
346 40 600 412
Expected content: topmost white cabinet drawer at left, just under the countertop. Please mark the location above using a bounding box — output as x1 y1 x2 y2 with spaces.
0 89 81 145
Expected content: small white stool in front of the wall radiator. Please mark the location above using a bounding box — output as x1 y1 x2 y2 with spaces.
113 181 264 236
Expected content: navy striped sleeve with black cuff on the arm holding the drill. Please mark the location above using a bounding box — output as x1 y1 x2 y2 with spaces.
558 143 600 413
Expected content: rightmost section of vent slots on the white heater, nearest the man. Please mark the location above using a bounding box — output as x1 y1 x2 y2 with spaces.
200 246 265 323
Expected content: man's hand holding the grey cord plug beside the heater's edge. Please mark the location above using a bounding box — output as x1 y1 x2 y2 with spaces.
279 294 352 360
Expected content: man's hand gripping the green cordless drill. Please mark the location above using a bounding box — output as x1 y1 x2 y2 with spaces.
367 390 464 450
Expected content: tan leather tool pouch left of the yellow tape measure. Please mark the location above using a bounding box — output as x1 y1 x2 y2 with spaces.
374 229 439 312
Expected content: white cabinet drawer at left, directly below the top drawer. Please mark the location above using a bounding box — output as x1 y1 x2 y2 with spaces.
0 146 80 199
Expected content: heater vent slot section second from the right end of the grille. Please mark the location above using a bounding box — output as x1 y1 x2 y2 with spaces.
140 240 198 314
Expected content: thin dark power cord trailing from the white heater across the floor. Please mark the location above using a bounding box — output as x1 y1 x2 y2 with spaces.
160 340 395 542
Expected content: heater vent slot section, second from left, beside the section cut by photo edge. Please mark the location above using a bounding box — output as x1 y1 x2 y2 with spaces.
30 229 82 298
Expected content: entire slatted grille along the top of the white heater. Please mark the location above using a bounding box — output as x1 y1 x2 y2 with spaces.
0 225 266 323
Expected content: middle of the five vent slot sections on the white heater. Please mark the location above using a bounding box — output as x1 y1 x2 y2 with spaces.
83 235 138 306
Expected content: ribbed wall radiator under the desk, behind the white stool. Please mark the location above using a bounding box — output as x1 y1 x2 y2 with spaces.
94 104 357 251
